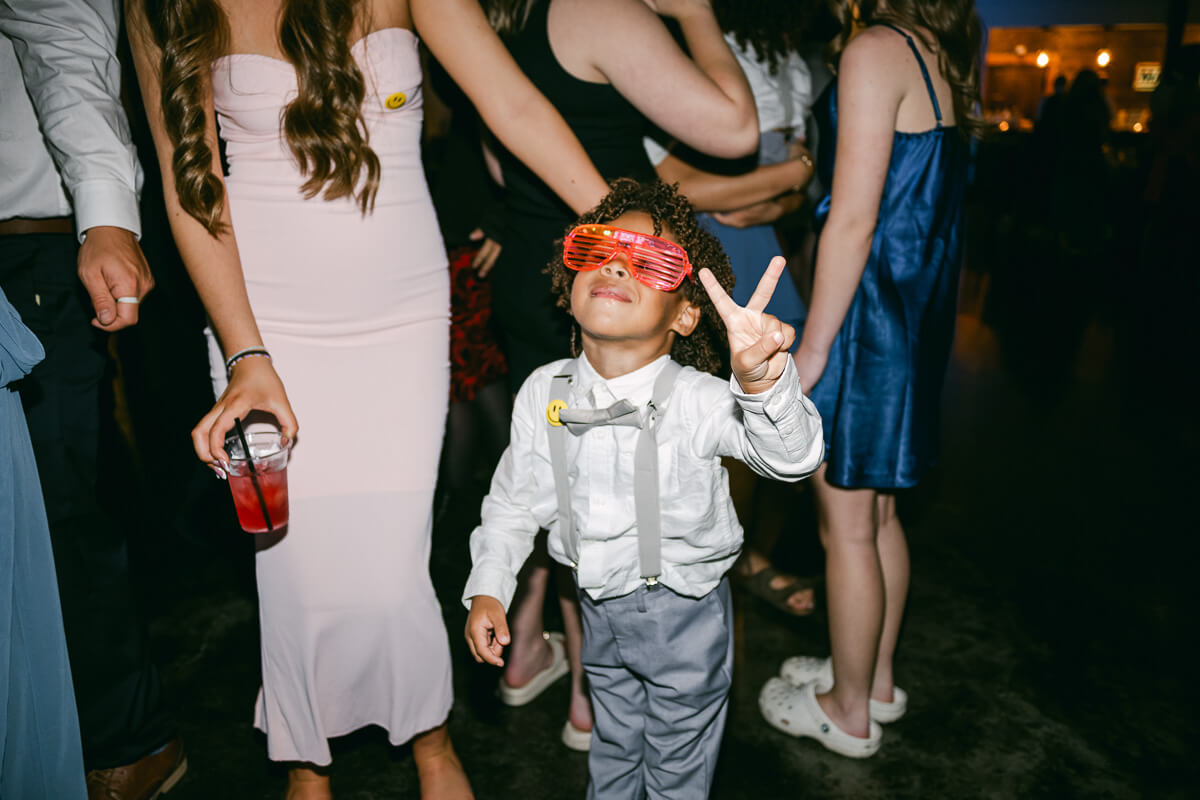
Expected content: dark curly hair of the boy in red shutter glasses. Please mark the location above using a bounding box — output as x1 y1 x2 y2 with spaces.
546 178 733 373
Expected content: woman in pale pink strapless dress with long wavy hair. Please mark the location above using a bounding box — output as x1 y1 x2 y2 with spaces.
128 0 607 798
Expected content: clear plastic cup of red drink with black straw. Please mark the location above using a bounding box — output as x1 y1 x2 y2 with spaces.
226 431 290 534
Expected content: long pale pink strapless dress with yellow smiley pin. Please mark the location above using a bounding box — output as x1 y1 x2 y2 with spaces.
210 28 451 765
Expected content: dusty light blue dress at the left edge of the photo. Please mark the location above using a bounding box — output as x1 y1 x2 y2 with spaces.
0 290 88 800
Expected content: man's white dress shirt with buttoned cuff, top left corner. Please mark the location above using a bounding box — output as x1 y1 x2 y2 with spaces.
0 0 142 235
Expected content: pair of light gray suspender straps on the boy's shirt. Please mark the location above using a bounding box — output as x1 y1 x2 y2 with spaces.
546 361 683 585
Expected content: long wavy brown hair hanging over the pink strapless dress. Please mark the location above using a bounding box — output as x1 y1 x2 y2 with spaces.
128 0 379 236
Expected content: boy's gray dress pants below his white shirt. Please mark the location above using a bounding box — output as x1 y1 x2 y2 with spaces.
580 578 733 800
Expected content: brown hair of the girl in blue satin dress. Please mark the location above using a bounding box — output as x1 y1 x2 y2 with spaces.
833 0 988 137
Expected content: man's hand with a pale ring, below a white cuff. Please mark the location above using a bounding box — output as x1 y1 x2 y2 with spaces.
79 225 154 332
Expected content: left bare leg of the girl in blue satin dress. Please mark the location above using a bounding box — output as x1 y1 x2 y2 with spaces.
812 464 884 738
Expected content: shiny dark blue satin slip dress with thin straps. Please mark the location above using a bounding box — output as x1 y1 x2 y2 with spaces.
811 29 970 489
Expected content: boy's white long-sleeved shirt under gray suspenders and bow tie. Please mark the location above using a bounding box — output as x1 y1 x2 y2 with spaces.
463 356 824 608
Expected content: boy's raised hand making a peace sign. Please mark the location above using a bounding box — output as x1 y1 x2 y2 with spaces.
700 255 796 395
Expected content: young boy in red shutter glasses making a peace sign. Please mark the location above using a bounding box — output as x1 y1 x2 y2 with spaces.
463 180 824 800
